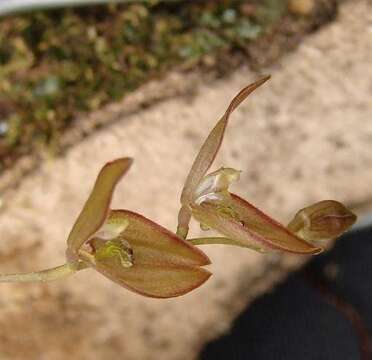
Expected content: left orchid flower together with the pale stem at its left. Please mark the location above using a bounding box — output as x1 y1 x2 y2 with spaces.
0 158 211 298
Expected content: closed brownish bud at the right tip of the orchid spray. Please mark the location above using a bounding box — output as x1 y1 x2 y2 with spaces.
288 200 357 241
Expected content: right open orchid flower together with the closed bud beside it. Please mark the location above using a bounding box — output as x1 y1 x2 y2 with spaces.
177 76 356 254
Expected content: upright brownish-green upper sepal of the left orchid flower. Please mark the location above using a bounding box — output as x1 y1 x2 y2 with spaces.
67 158 132 258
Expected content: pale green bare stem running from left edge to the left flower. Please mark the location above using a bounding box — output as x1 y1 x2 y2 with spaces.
0 262 87 282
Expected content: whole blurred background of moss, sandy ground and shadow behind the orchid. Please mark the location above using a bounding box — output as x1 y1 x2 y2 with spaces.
0 0 372 360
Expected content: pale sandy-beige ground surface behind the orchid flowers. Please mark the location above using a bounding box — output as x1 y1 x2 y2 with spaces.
0 0 372 360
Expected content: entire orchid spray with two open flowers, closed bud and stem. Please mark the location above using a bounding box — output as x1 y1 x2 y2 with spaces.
0 77 356 298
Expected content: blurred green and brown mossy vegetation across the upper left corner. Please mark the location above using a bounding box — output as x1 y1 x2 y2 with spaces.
0 0 287 170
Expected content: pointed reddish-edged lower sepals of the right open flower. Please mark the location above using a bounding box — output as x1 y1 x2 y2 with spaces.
192 194 322 254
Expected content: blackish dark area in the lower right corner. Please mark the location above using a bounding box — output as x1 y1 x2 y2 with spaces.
200 227 372 360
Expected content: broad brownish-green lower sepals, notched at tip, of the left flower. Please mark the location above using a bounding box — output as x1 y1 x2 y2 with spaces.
87 210 211 298
